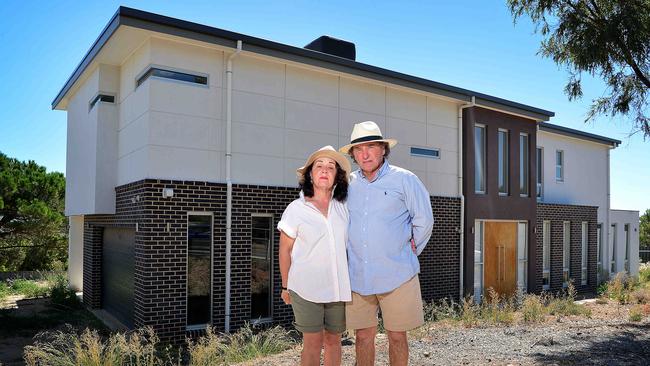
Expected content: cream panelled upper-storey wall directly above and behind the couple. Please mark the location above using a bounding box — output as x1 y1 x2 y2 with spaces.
111 38 458 196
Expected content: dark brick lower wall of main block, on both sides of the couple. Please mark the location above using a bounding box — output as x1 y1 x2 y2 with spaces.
84 179 460 342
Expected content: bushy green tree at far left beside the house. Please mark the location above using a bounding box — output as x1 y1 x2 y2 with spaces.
0 152 67 271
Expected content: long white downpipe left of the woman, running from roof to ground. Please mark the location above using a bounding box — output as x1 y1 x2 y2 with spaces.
224 41 242 333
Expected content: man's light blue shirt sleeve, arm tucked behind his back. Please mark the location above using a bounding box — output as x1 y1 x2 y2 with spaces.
404 175 433 255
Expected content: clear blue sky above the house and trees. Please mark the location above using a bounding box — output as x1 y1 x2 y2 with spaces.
0 0 650 211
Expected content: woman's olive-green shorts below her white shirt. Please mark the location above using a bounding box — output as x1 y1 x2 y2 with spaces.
289 290 345 334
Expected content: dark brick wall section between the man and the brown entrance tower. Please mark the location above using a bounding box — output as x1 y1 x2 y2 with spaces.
419 197 460 301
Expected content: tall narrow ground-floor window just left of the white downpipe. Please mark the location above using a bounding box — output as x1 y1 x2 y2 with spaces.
187 214 212 329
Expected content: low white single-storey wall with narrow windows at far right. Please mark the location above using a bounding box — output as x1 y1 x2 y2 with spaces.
610 210 639 276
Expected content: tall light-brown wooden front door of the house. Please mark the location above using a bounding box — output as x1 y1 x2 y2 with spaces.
483 221 517 296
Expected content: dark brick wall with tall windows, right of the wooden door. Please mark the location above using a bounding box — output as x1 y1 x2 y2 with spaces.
528 203 598 293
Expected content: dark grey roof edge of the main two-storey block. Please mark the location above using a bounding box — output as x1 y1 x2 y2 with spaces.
52 6 555 121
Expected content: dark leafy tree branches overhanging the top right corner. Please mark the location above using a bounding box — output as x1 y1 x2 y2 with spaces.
508 0 650 139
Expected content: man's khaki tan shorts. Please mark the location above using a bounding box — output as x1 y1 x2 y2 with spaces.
345 275 424 332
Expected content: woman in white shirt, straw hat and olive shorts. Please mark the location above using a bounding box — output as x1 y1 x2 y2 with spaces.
278 146 351 366
